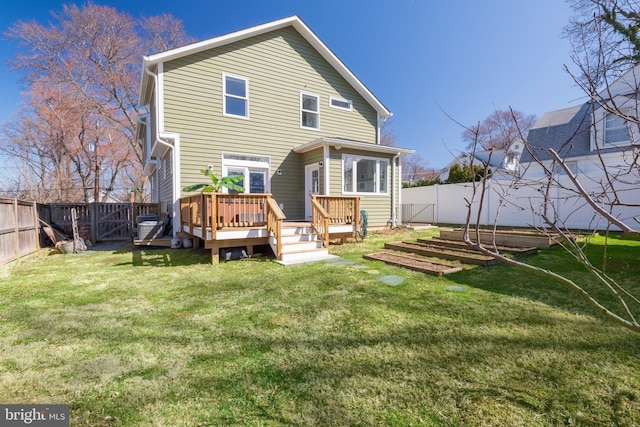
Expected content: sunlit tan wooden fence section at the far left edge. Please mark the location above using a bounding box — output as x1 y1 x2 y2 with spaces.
0 198 40 265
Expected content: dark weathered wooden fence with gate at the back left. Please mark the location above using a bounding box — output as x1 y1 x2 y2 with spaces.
38 203 165 243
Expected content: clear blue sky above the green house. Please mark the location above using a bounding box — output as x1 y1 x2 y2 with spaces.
0 0 585 176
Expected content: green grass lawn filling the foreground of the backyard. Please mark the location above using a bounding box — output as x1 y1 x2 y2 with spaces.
0 230 640 426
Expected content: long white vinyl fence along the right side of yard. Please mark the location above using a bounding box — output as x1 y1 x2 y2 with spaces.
401 175 640 230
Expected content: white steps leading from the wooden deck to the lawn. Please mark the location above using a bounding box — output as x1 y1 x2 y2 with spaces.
269 222 332 265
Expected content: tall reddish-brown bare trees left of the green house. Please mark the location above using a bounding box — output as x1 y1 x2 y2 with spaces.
0 3 192 200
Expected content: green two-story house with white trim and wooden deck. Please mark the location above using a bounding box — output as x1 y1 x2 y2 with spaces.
137 16 413 261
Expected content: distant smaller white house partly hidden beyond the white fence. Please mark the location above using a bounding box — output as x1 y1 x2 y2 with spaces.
438 141 525 182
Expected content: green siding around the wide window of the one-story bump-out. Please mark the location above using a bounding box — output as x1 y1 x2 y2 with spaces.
329 147 397 227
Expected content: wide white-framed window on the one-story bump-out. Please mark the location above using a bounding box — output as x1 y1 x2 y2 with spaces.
342 154 389 194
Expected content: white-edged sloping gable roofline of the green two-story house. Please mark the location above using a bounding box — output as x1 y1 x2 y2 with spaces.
138 15 392 118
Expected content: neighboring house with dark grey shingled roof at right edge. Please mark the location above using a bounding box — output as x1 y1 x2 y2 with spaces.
520 66 640 178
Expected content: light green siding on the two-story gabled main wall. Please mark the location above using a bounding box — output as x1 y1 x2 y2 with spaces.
162 27 377 219
